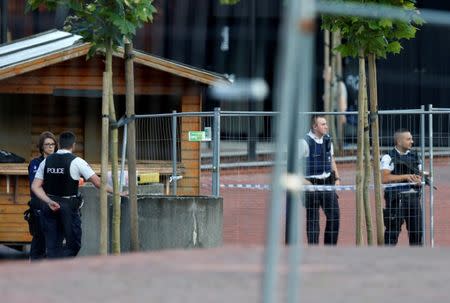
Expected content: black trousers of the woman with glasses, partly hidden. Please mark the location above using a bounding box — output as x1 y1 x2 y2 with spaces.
30 198 46 261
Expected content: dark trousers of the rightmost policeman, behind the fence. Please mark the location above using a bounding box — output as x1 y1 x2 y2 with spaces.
383 192 423 245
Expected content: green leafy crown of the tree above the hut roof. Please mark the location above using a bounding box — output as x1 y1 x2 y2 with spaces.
27 0 156 56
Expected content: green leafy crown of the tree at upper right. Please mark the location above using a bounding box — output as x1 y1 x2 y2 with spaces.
322 0 423 58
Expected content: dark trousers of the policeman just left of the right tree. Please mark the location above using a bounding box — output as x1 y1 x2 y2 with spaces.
305 179 340 245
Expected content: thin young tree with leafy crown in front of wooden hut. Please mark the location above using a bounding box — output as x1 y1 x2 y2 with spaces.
27 0 156 255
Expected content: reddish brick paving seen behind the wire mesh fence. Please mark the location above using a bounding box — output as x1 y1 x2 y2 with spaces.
201 157 450 246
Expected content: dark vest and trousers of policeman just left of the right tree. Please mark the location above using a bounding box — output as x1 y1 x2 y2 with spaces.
305 135 339 245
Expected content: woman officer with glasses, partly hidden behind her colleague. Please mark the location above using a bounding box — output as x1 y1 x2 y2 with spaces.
28 131 58 261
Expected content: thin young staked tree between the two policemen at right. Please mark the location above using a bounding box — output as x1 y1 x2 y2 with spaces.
322 0 423 245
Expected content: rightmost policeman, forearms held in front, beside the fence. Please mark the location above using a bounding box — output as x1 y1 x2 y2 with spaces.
381 129 423 245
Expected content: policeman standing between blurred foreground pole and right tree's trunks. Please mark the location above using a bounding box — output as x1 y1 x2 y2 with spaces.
300 115 340 245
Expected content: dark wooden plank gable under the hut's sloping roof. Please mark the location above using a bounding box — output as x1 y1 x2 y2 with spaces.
0 56 186 95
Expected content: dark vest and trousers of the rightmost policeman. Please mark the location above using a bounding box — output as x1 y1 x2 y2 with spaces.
383 148 423 245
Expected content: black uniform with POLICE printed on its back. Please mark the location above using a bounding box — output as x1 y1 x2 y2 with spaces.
43 153 81 258
